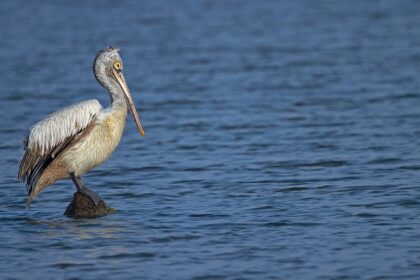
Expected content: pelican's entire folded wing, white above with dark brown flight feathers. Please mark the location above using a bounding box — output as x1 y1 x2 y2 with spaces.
18 99 102 184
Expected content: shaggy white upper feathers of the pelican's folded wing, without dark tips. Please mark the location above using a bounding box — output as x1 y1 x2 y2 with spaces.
28 99 102 156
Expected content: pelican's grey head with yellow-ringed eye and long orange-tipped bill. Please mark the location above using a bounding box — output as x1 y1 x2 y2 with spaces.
93 47 144 137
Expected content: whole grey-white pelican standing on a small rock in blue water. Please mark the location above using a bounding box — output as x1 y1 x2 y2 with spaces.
18 47 144 207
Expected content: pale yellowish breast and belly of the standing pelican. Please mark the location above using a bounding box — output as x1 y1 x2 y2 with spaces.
63 109 127 176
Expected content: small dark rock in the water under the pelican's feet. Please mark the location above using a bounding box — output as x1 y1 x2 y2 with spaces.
64 192 116 218
